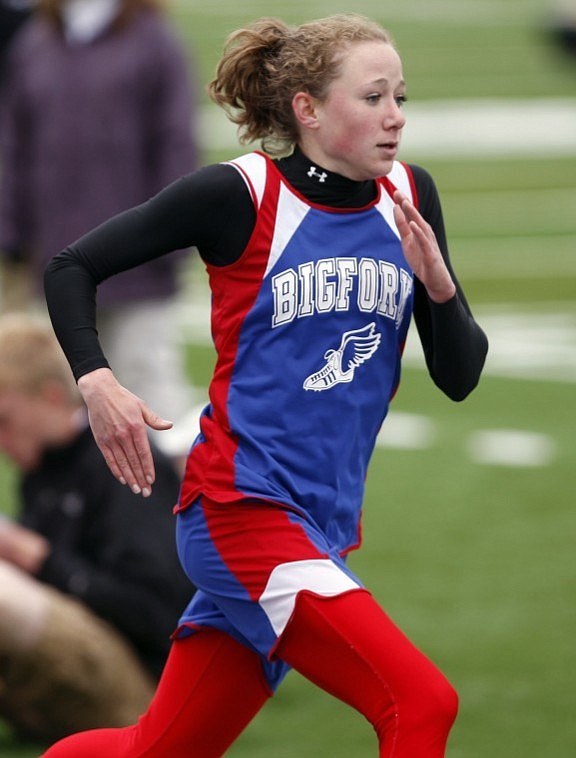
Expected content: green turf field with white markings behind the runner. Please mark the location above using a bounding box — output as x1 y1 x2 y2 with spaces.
0 0 576 758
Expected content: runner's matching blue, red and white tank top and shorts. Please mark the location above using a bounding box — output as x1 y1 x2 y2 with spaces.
173 153 412 688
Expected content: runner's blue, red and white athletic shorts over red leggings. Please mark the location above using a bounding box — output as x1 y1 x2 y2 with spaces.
175 497 362 689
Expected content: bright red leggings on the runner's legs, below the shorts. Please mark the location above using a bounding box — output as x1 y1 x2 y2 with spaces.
44 590 457 758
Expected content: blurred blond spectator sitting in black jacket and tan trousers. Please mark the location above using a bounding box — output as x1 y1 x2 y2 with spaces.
0 314 190 740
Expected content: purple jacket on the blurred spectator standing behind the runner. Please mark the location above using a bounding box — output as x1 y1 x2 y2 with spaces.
0 11 197 305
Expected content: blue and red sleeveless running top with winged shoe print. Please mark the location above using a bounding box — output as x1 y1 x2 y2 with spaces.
177 152 416 553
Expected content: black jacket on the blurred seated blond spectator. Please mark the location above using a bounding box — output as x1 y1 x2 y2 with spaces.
20 428 193 676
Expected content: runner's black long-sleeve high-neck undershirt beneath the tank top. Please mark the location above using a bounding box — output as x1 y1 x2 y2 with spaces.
45 151 487 400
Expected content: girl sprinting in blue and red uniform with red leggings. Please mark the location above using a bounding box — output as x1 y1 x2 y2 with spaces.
45 14 487 758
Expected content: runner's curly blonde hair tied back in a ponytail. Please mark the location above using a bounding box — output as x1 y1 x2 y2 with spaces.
208 13 393 154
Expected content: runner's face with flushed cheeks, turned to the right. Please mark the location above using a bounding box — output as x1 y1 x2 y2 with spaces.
304 41 406 181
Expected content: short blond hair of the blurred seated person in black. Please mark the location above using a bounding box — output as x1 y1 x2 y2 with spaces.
0 313 81 405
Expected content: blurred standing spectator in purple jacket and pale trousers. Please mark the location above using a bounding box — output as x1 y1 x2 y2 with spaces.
0 0 198 460
